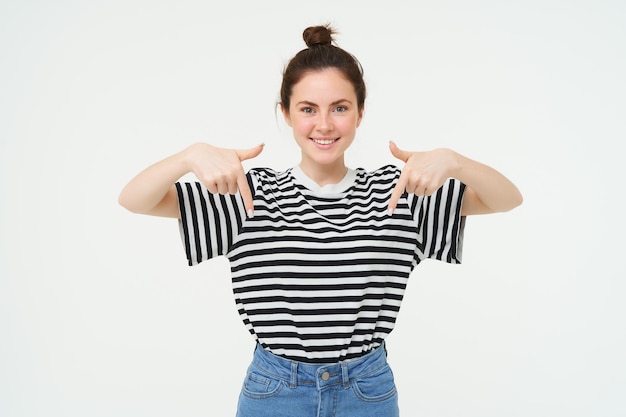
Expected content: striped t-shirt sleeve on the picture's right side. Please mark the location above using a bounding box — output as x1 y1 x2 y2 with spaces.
408 178 465 264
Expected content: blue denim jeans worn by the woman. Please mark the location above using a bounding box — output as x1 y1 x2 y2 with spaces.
237 344 399 417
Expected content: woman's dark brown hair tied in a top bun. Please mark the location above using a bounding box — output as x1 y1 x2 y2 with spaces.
280 25 366 111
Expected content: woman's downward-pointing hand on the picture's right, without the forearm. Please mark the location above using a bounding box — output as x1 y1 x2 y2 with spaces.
387 142 458 213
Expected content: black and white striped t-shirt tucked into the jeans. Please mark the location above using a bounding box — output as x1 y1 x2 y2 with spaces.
176 165 465 363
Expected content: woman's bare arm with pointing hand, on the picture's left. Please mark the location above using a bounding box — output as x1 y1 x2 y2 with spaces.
118 143 263 218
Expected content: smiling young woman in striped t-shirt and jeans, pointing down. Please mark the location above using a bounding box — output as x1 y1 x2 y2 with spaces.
119 26 522 417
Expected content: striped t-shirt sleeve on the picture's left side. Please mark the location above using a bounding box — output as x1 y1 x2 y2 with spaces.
176 182 245 266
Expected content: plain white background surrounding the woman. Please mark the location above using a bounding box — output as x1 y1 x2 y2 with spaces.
0 0 626 417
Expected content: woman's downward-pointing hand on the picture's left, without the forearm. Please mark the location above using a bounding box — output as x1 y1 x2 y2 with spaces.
184 143 263 217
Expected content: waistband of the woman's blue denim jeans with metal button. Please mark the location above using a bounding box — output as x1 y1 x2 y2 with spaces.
247 343 387 389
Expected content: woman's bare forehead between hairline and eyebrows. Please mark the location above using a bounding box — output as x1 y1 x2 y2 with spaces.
292 68 356 104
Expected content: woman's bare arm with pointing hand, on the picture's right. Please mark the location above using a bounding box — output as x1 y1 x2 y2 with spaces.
389 142 523 216
